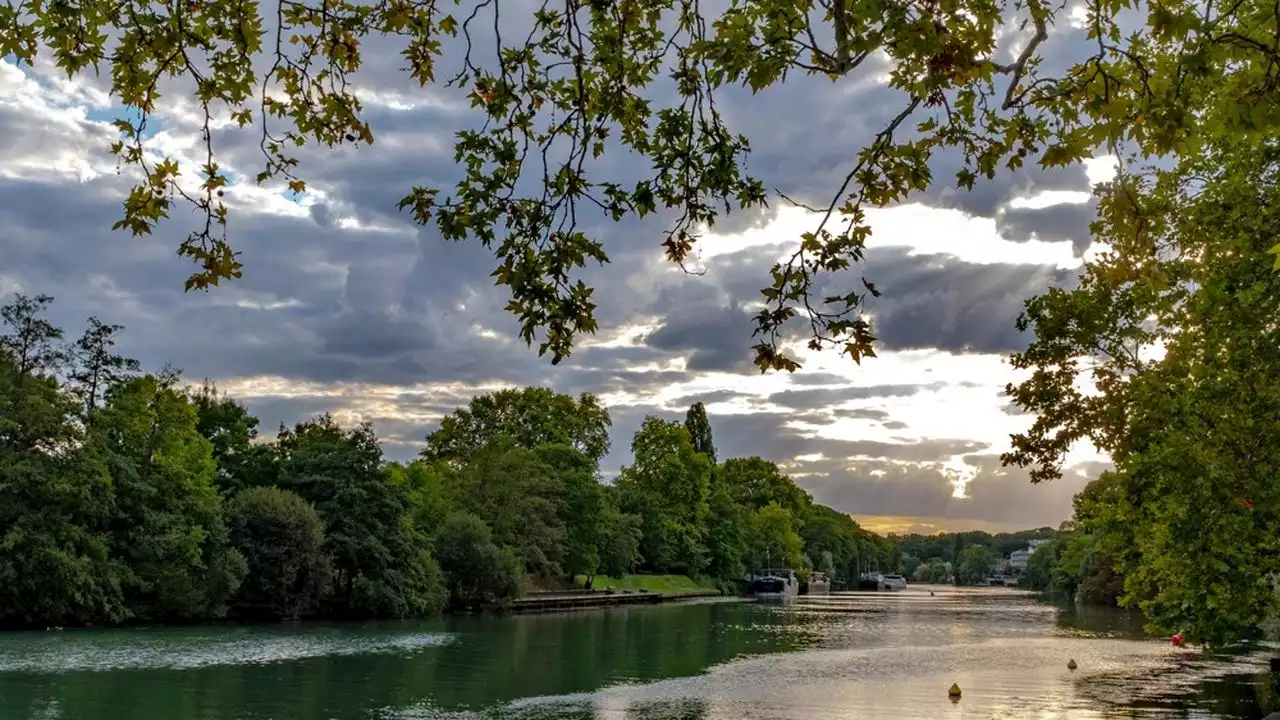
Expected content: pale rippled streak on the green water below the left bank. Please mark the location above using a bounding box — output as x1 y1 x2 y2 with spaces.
0 626 453 674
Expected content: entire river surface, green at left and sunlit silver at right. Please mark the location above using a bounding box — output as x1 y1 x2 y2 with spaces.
0 585 1280 720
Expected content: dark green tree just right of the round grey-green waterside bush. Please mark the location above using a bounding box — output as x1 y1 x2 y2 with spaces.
276 415 439 618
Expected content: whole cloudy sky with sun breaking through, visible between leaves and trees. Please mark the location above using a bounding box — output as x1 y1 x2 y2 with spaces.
0 7 1108 530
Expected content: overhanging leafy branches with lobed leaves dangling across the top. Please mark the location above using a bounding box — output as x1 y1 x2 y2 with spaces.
0 0 1280 370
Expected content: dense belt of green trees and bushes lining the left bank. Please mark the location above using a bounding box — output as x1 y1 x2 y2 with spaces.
0 295 897 629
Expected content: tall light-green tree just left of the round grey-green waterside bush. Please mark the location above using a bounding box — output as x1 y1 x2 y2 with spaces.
88 375 244 620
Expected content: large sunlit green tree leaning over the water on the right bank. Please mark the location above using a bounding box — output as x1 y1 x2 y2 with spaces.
1006 140 1280 644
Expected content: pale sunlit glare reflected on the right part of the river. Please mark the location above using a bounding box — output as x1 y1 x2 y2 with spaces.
473 588 1270 720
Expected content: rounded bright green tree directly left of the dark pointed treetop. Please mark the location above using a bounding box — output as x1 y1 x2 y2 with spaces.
617 416 710 574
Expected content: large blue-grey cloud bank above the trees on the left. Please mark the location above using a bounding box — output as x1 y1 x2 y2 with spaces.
0 169 548 383
